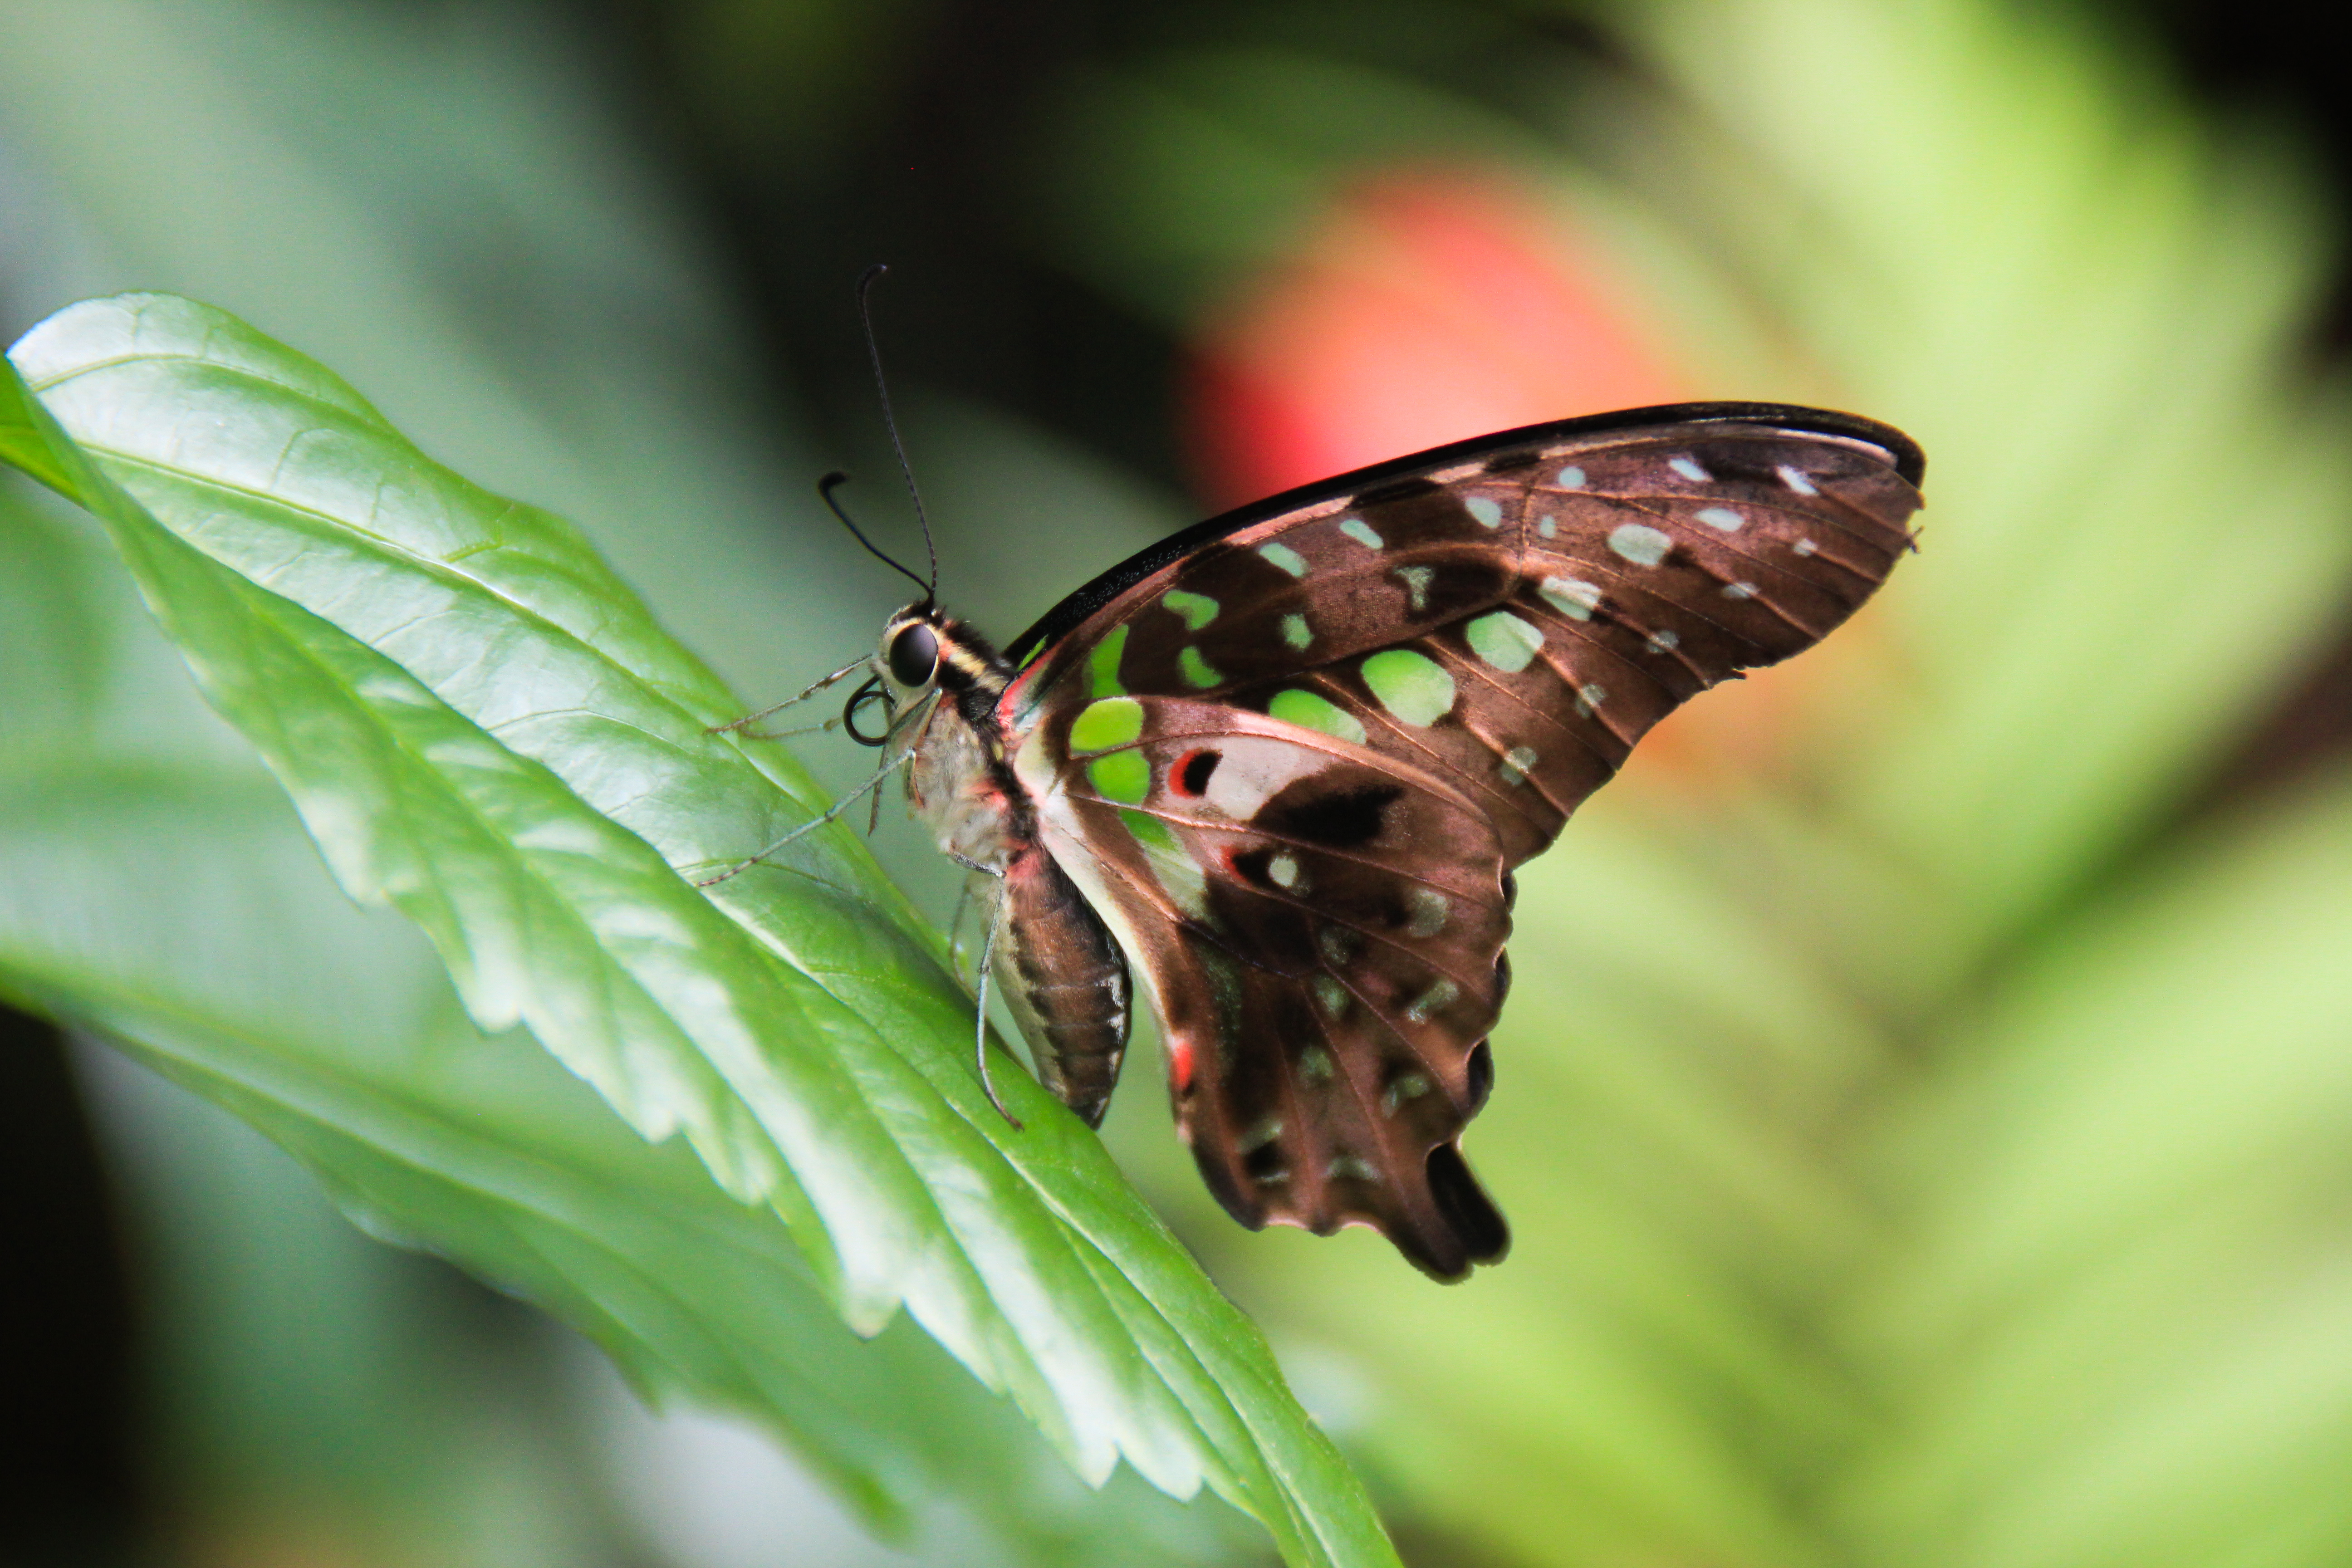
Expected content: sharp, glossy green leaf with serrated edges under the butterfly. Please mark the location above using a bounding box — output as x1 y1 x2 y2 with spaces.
7 296 1392 1563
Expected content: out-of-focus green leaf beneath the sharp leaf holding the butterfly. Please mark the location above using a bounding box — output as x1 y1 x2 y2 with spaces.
0 487 1247 1563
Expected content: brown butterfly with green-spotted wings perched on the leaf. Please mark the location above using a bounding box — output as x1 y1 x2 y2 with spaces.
734 402 1924 1279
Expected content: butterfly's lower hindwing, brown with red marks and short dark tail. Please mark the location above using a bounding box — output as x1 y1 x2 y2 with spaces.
1023 696 1510 1277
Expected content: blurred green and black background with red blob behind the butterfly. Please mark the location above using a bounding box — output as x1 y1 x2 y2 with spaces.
0 0 2352 1568
